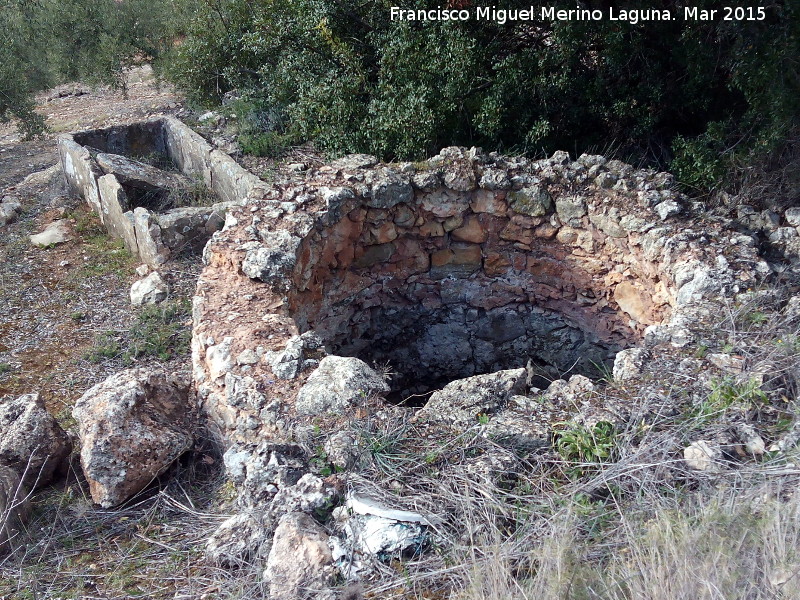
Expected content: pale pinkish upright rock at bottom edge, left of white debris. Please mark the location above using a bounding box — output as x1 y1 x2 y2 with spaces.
264 513 335 600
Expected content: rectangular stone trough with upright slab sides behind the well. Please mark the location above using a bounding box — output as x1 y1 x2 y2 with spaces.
58 117 263 267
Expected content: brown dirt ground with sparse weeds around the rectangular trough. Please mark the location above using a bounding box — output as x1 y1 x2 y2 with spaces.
0 66 199 416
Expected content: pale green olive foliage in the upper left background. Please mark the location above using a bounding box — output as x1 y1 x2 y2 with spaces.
0 0 196 136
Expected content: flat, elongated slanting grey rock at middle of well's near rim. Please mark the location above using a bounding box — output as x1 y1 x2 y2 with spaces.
415 368 527 429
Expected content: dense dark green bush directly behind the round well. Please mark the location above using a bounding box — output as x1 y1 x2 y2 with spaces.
173 0 800 187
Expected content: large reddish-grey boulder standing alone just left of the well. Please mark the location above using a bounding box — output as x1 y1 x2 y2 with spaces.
72 369 195 508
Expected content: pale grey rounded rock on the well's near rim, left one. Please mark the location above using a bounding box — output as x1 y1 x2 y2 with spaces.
295 356 389 415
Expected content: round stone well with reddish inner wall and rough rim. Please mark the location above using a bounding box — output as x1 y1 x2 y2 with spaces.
193 148 768 441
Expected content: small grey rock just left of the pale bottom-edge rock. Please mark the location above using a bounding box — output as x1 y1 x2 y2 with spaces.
206 511 269 567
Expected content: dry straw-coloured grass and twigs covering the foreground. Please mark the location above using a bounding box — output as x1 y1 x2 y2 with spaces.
0 287 800 600
